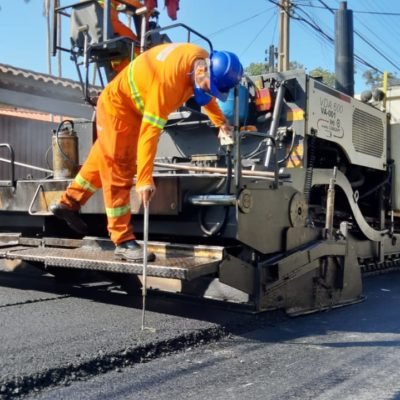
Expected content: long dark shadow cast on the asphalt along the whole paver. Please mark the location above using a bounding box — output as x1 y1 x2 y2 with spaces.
0 264 400 340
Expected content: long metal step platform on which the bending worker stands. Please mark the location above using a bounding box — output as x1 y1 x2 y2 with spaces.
0 237 223 280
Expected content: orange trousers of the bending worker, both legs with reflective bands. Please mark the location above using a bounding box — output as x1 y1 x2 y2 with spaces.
60 98 142 245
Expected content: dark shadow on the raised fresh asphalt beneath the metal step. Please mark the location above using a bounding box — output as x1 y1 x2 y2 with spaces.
0 264 287 333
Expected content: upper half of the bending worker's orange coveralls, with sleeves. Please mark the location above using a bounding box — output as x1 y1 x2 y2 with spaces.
99 43 225 189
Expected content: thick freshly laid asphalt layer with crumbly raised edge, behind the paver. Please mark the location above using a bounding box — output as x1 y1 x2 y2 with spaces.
0 260 276 398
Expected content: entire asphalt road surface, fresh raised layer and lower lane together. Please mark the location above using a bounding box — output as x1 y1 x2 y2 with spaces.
0 260 400 400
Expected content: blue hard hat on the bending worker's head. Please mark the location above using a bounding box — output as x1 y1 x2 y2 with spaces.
210 51 243 101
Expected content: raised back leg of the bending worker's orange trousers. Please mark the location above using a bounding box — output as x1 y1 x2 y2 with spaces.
60 142 101 210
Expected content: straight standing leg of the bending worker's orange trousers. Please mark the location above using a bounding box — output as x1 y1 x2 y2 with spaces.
97 101 141 244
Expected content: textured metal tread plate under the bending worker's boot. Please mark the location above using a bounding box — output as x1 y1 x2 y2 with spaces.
0 245 220 280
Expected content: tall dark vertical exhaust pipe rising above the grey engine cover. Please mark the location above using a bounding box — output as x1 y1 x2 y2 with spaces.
335 1 354 97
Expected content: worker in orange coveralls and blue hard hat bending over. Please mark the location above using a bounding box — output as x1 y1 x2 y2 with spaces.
50 43 243 262
